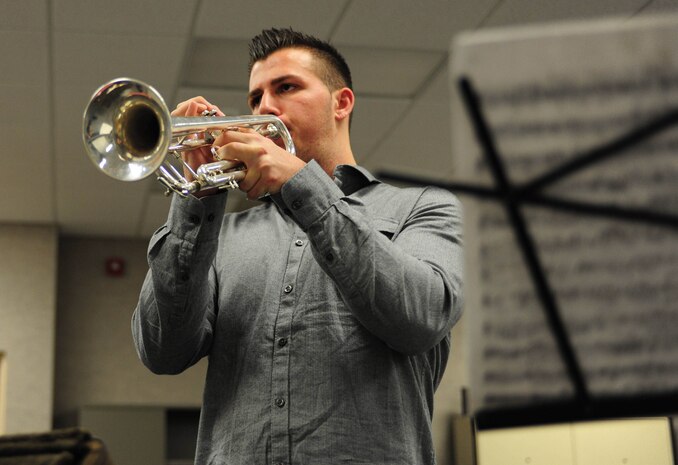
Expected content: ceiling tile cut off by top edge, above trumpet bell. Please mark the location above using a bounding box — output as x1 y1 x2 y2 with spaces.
52 0 197 34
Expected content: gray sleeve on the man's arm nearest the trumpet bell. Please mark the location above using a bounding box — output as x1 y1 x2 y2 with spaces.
132 191 226 374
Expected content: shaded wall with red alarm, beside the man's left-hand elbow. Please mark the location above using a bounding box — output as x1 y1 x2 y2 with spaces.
54 238 206 426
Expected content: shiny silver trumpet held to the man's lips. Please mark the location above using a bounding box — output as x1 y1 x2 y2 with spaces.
83 78 295 196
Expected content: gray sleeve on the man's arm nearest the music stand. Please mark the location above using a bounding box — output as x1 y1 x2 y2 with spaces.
281 162 463 354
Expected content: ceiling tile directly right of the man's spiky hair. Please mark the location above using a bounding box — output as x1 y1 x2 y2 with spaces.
341 47 445 97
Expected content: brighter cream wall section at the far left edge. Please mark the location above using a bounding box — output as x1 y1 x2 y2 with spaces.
0 225 57 434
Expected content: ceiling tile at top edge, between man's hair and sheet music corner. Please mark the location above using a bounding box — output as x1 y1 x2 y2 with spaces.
332 0 496 51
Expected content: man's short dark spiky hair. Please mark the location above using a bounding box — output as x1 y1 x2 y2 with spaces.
248 28 353 90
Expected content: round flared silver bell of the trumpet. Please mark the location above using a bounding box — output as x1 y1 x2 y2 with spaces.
83 78 172 181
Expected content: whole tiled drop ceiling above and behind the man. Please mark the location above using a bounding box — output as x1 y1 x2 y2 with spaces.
0 0 678 237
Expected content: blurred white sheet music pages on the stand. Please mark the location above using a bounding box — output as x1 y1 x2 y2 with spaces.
452 17 678 410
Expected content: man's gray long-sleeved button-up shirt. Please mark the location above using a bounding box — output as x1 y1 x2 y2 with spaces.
132 162 462 465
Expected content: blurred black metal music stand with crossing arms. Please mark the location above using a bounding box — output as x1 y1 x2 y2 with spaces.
379 77 678 429
